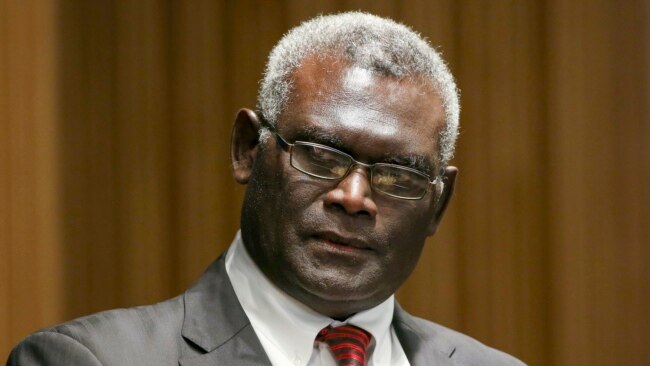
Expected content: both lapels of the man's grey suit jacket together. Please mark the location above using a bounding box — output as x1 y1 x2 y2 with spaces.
180 255 456 366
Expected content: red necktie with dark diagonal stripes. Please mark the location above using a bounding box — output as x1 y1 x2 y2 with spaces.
316 325 371 366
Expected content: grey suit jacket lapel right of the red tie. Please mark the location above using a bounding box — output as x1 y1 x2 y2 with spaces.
393 302 457 366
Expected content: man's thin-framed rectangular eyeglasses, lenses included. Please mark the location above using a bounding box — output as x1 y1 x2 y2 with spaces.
271 129 441 200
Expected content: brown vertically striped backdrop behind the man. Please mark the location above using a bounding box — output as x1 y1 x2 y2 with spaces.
0 0 650 365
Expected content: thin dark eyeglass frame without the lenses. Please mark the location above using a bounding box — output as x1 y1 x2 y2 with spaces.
262 123 444 201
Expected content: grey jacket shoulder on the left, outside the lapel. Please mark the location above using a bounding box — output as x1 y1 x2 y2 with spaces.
8 296 184 365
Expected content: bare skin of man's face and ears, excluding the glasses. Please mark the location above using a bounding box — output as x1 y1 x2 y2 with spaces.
231 59 457 319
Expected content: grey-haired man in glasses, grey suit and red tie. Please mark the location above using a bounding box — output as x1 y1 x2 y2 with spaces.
8 13 521 366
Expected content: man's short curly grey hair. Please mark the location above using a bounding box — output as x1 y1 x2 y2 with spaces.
257 12 460 165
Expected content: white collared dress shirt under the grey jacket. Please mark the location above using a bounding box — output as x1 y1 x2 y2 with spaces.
226 232 409 366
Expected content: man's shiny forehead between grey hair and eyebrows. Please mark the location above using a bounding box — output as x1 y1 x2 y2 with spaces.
278 57 444 160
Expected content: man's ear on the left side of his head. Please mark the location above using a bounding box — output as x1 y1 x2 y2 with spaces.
230 108 261 184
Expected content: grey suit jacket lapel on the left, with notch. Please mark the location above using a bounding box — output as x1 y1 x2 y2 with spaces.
179 255 271 366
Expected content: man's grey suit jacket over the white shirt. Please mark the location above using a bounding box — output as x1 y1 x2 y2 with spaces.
7 256 523 366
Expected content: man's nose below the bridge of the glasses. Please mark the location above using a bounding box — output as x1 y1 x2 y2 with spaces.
325 166 377 218
